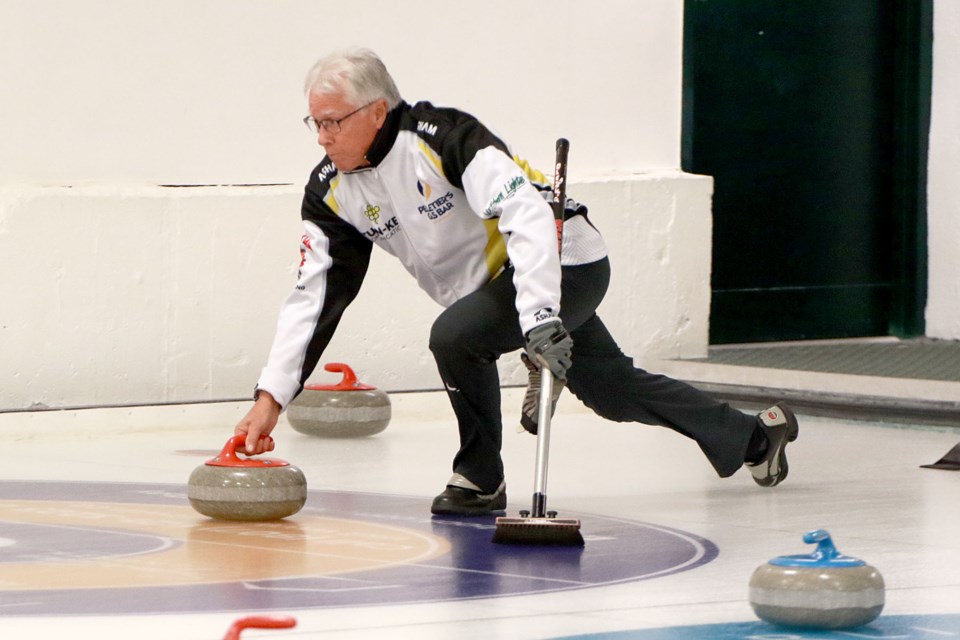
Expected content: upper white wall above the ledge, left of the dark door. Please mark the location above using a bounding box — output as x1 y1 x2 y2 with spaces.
0 0 683 185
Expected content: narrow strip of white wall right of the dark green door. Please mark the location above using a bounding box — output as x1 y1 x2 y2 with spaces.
927 0 960 340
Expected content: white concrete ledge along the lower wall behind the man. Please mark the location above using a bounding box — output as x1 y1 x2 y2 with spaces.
0 176 712 411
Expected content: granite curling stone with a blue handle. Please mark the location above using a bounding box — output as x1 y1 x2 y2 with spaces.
750 529 884 629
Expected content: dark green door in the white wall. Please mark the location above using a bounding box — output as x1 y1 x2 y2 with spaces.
682 0 932 344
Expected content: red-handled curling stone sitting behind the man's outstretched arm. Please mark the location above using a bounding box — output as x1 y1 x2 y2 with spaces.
287 362 390 438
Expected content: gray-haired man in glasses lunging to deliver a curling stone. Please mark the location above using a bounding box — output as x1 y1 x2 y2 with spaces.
236 50 798 515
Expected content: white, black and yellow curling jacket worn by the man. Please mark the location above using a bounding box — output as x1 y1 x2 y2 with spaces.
251 102 606 408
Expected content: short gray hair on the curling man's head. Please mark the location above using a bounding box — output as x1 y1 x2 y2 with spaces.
303 49 400 109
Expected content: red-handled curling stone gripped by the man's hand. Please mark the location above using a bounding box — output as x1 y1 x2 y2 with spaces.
187 435 307 522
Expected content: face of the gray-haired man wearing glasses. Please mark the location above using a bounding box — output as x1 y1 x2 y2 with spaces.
308 93 387 171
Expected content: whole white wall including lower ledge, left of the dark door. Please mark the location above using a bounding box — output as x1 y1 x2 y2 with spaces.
0 0 696 410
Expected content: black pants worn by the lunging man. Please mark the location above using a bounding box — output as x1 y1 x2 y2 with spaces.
430 258 757 492
